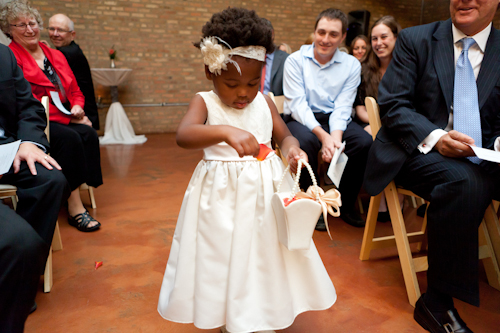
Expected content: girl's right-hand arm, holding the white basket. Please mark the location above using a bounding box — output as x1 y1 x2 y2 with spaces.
265 96 309 172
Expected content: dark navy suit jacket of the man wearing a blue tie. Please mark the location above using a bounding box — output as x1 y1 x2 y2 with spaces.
365 20 500 195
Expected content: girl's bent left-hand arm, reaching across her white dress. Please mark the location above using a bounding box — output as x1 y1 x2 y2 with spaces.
176 95 259 157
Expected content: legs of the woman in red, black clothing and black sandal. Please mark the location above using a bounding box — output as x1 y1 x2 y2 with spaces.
50 122 102 231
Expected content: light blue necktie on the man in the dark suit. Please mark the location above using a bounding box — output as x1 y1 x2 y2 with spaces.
453 38 482 164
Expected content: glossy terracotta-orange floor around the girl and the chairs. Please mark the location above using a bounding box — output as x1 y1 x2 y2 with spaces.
26 134 500 333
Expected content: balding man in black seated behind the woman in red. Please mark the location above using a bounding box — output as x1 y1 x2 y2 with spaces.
49 14 99 130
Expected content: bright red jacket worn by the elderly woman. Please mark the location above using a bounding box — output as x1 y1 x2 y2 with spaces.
9 41 85 125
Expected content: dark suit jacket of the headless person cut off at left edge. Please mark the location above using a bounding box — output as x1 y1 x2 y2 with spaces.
0 44 49 151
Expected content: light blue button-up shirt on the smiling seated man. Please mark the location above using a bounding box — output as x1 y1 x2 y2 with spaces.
283 45 361 132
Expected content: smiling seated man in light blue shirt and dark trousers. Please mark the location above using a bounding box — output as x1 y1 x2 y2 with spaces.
283 8 372 230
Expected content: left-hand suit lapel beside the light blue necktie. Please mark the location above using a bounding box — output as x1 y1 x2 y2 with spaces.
432 19 455 112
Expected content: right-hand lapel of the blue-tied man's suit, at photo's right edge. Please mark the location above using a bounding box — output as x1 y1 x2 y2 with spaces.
477 27 500 110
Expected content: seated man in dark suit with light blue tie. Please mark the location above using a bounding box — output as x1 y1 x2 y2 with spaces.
365 0 500 332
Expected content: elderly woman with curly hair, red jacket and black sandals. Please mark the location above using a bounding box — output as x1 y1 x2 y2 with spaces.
0 0 102 231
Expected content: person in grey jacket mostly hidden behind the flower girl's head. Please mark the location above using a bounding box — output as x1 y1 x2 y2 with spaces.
261 18 288 96
